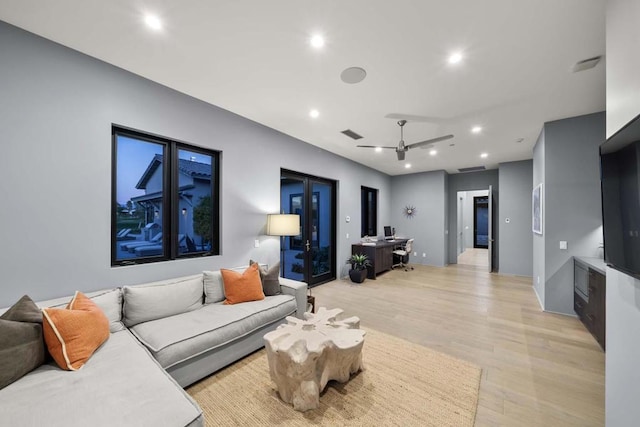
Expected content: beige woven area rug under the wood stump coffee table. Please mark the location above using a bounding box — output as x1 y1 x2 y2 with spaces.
187 329 481 427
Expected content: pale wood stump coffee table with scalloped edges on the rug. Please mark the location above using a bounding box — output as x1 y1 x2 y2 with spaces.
264 307 366 411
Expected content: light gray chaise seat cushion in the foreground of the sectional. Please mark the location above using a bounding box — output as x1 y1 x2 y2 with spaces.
0 330 202 427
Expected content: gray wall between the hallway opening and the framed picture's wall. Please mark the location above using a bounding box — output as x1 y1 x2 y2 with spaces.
497 160 533 276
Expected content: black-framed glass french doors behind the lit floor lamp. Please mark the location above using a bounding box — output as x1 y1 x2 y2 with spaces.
280 170 336 286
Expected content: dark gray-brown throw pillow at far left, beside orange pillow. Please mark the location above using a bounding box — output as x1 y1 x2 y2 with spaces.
0 295 45 389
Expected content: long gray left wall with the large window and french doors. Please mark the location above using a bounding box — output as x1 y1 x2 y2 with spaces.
0 22 391 307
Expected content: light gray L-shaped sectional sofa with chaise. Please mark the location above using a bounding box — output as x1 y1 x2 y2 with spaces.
0 269 307 427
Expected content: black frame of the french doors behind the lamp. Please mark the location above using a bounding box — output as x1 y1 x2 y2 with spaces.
280 169 338 287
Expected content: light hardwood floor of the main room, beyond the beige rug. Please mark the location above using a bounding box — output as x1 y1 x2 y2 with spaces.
312 265 604 426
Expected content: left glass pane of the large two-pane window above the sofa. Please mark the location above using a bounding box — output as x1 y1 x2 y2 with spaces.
113 134 165 261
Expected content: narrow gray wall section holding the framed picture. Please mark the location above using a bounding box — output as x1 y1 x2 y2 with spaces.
529 127 547 309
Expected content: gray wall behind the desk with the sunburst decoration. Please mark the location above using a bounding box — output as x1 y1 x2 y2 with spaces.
391 171 448 266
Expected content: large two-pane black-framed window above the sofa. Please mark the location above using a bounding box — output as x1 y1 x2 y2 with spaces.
111 126 220 266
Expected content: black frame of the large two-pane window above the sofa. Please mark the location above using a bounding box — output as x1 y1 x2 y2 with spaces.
110 124 222 267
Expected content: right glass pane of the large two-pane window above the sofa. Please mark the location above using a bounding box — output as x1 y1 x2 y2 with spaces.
176 149 215 254
